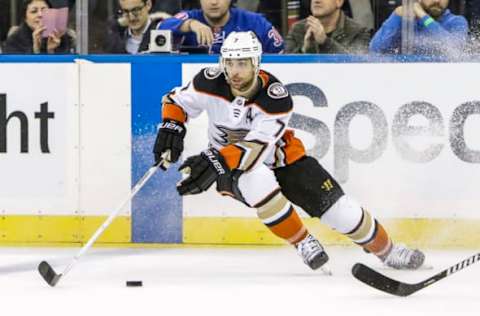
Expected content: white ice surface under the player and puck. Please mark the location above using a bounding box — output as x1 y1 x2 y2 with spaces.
0 246 480 316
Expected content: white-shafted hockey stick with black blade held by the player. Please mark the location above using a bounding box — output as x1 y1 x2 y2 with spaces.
38 156 170 287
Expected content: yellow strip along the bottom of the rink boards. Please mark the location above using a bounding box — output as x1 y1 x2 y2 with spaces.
0 215 480 249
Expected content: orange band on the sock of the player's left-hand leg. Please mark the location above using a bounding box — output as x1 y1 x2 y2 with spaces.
267 207 308 244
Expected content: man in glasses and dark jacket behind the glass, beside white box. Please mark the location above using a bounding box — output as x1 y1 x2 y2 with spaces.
105 0 169 54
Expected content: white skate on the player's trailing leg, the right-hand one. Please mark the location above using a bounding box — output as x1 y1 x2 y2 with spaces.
382 244 425 270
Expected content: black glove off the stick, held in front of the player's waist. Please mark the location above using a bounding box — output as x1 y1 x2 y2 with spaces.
177 148 230 195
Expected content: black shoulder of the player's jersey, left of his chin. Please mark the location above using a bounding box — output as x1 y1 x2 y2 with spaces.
193 67 230 99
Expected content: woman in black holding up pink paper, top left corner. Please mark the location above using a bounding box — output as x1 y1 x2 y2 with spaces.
4 0 75 54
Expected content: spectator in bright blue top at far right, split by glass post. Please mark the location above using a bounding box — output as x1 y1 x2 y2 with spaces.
370 0 468 56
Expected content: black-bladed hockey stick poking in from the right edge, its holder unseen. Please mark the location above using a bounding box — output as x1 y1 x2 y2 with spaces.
352 253 480 296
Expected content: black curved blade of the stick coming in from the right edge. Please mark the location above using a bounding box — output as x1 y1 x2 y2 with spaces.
352 263 417 296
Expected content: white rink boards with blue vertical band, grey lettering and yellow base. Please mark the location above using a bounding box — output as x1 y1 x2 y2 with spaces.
0 56 480 247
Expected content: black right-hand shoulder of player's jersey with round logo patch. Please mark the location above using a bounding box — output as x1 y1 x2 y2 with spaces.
251 70 293 114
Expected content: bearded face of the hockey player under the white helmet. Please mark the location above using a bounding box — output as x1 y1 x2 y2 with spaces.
225 58 255 91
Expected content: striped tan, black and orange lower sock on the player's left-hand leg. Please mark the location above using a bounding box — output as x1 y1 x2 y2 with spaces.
255 192 308 245
